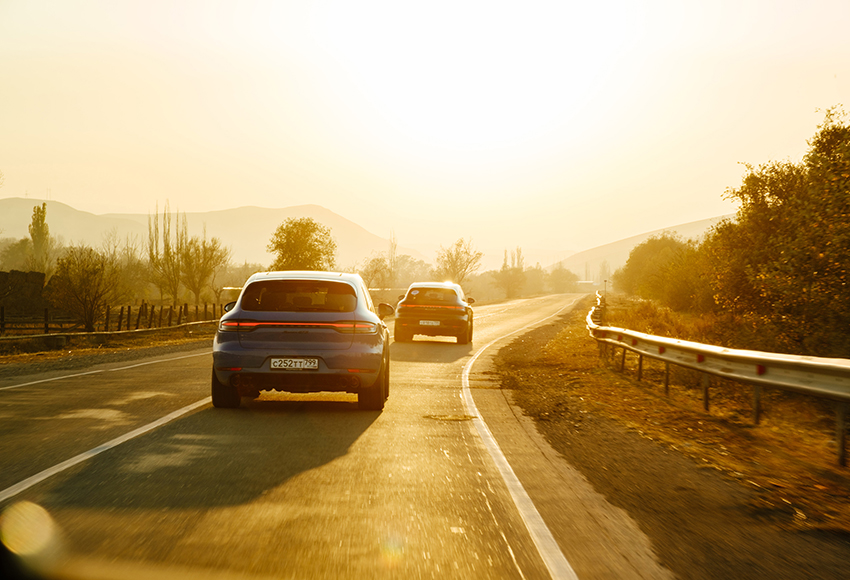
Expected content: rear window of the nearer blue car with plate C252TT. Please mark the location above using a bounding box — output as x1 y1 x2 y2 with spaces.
242 280 357 312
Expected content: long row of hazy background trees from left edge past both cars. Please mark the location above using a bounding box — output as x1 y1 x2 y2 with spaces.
0 187 578 332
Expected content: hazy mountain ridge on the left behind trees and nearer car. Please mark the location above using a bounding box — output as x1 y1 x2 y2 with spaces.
0 198 428 268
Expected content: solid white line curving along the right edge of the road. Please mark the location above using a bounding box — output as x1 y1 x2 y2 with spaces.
461 300 578 580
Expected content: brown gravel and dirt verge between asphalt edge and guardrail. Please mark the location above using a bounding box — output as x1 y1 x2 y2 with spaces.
497 300 850 580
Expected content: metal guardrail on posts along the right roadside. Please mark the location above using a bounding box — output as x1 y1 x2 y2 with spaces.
586 291 850 466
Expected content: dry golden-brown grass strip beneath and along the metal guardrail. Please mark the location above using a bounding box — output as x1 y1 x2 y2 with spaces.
537 297 850 531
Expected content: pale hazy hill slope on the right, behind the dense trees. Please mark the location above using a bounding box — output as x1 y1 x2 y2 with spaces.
547 214 734 281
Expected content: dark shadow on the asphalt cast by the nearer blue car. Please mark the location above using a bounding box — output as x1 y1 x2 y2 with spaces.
49 400 380 510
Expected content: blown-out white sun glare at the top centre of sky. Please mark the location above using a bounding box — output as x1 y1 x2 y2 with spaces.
314 2 640 156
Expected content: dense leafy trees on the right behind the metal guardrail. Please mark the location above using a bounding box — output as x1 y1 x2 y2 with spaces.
613 108 850 357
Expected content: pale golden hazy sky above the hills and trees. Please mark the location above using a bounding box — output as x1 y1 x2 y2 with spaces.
0 0 850 258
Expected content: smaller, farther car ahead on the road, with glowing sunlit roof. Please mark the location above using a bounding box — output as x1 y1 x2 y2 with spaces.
393 282 475 344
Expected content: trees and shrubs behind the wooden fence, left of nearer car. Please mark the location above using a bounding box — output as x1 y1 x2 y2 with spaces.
0 203 238 332
